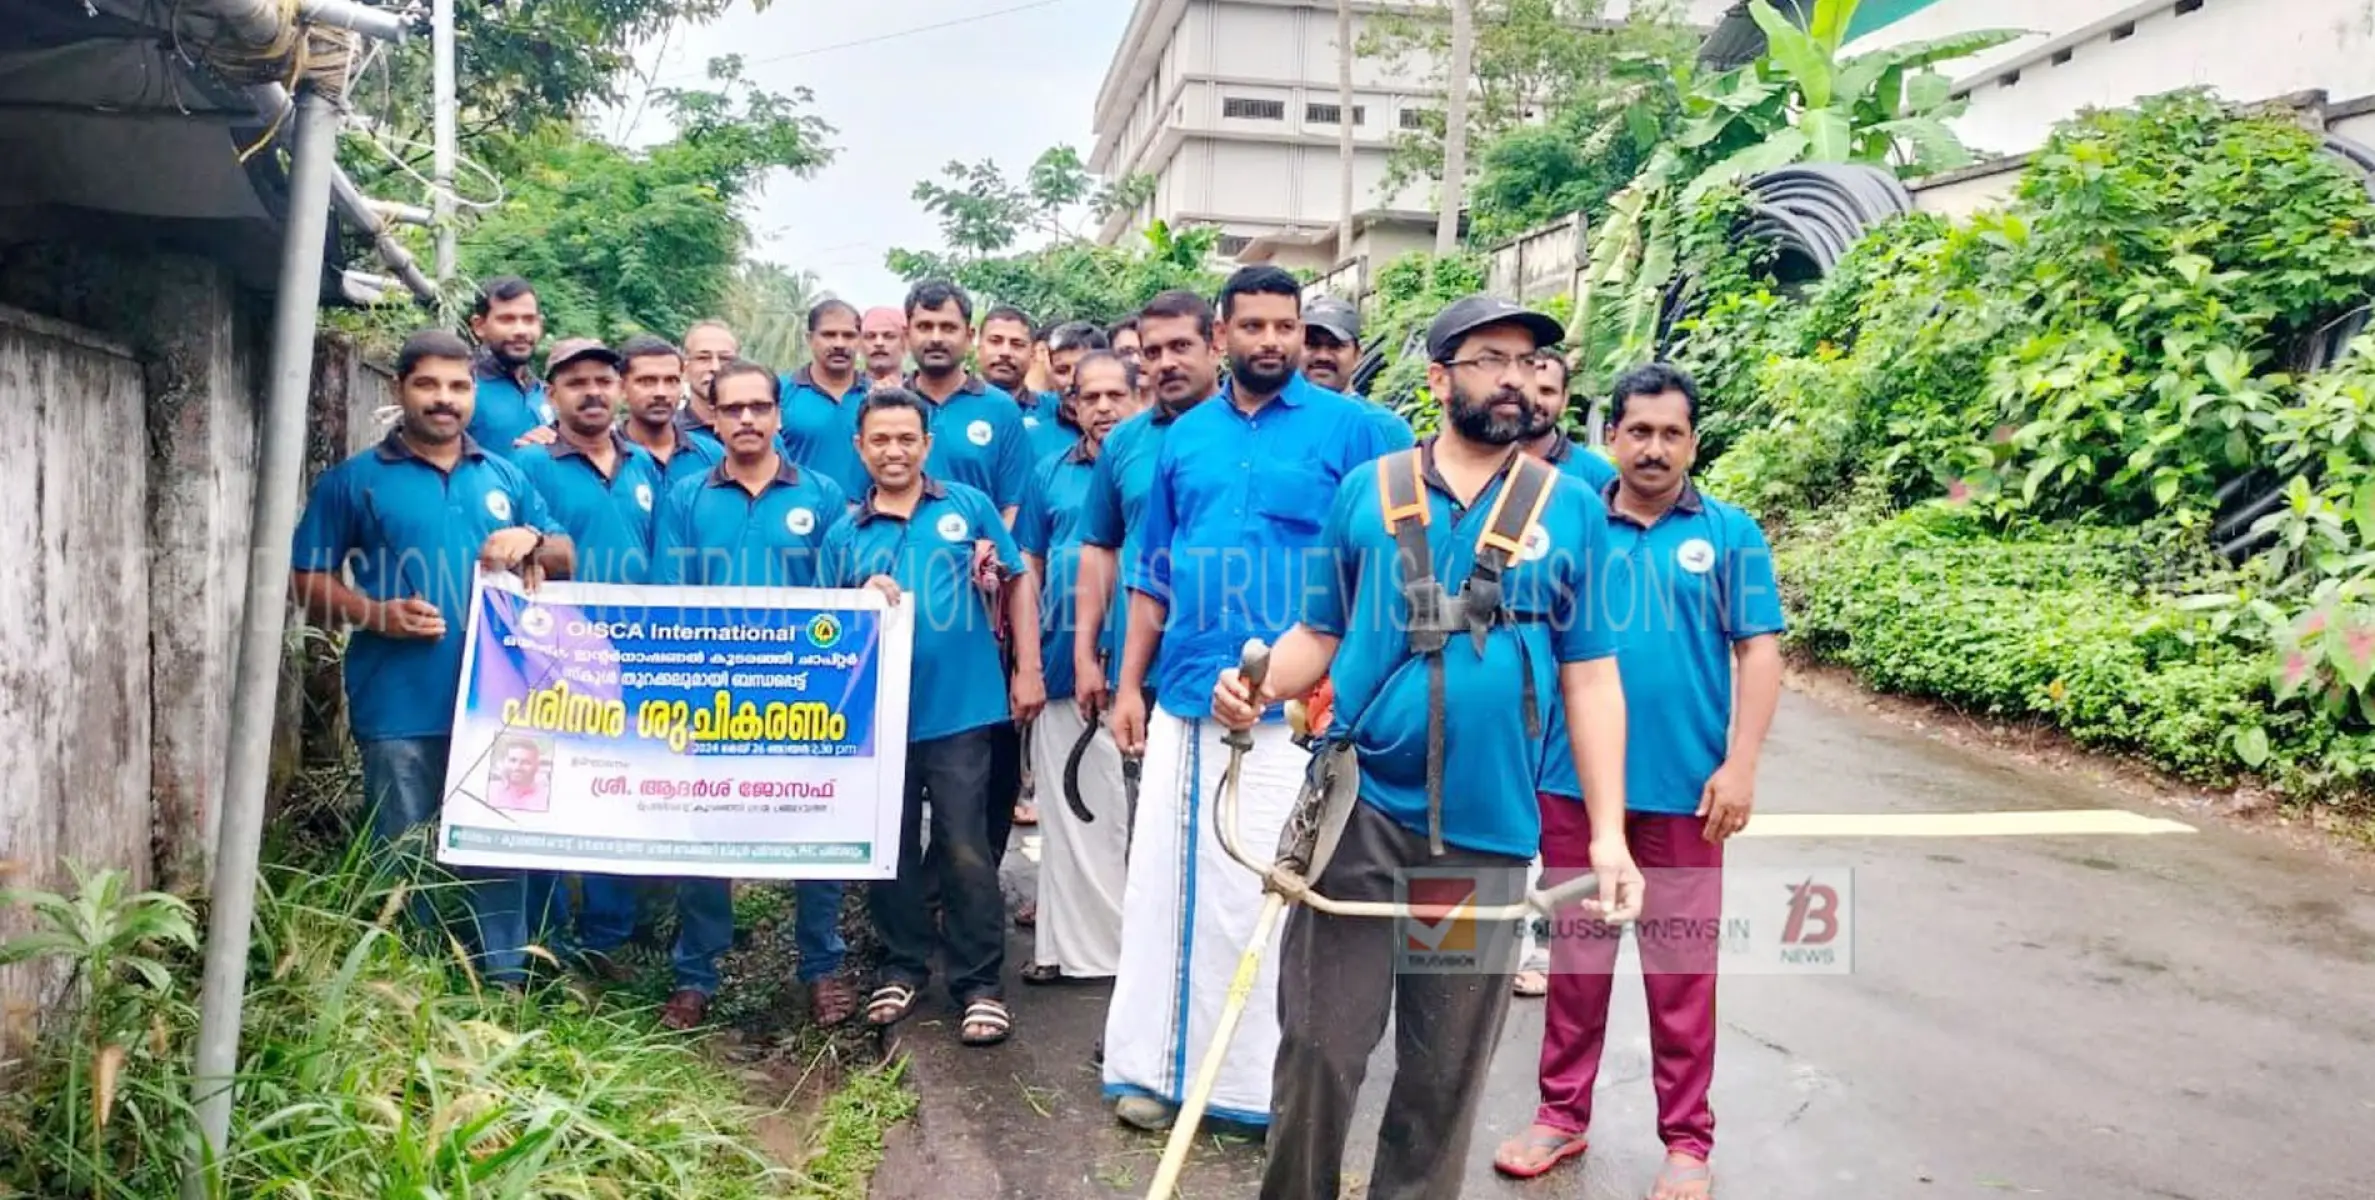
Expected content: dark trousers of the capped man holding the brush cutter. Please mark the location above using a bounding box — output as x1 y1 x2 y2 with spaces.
1261 803 1527 1200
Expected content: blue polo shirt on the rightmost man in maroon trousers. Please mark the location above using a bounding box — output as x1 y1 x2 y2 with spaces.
1541 485 1786 815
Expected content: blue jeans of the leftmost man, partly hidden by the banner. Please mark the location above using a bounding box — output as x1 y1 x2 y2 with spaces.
356 737 568 984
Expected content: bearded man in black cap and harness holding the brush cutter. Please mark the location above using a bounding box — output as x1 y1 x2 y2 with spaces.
1211 297 1641 1200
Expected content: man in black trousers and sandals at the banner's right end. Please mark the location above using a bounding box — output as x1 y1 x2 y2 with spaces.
824 387 1047 1046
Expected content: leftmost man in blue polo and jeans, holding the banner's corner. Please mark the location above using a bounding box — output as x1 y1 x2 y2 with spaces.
290 330 575 989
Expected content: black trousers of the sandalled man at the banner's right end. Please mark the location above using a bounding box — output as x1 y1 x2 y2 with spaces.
867 722 1014 1005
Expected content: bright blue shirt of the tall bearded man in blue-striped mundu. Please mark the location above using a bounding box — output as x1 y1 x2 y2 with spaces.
1121 375 1389 718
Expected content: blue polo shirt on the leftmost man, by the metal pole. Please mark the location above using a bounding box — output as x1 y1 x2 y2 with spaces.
290 432 563 741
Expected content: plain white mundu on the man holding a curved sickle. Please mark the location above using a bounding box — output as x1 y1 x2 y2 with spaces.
1031 699 1131 979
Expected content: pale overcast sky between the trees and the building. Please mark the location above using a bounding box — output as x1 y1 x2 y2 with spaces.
608 0 1133 307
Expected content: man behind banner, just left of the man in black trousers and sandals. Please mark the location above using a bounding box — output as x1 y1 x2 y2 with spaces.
651 359 857 1029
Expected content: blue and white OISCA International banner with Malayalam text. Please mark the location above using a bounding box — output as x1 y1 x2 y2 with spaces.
437 573 914 879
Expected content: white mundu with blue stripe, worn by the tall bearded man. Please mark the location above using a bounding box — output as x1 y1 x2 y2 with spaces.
1104 708 1311 1124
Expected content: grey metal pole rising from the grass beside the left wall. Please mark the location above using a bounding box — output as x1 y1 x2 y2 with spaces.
183 86 337 1200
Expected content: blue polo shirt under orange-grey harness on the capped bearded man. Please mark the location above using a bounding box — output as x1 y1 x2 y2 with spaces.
1304 440 1617 858
